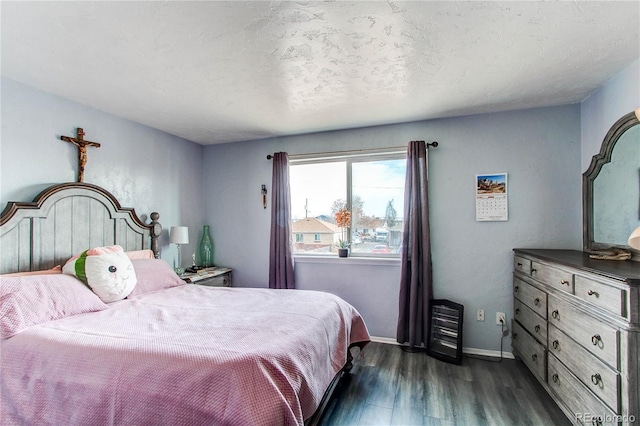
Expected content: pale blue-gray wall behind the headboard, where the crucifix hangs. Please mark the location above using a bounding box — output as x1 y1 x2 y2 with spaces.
0 78 204 263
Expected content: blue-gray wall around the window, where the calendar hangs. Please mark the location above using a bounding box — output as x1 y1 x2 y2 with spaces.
204 105 581 351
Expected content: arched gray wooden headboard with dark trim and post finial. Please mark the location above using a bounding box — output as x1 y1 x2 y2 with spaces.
0 183 162 273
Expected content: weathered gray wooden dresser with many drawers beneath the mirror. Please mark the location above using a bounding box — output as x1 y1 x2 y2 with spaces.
512 249 640 425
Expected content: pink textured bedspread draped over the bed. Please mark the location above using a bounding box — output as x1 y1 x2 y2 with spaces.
0 285 369 425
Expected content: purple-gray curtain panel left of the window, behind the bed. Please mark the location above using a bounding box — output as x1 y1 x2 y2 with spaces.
269 152 296 288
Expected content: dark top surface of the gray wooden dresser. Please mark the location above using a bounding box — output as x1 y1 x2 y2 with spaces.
514 248 640 285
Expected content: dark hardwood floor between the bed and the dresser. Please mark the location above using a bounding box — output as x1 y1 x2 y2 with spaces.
320 342 571 426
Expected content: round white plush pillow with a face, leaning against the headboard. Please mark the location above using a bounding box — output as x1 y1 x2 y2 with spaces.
62 246 137 303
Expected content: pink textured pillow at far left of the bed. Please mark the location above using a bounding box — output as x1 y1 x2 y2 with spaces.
0 274 107 339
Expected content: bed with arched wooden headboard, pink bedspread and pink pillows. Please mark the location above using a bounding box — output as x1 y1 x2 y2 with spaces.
0 183 369 425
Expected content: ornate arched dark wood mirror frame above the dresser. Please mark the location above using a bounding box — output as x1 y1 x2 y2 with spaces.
582 108 640 261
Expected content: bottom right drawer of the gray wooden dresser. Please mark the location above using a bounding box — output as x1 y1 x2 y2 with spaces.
549 354 618 425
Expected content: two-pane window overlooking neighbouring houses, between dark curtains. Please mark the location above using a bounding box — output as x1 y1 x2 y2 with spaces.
289 148 406 257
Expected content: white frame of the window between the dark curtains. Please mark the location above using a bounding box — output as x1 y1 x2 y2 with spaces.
289 147 407 259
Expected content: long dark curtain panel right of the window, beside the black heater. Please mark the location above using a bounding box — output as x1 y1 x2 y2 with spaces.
396 141 433 347
